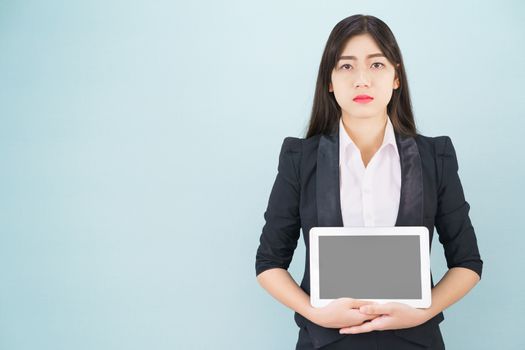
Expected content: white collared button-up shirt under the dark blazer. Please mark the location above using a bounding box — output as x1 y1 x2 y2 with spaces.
339 118 401 227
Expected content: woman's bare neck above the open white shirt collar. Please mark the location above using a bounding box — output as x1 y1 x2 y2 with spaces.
342 113 388 150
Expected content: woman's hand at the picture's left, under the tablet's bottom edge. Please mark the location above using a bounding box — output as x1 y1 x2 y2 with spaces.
311 298 380 328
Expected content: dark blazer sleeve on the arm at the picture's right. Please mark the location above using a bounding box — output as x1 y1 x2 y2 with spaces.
435 136 483 279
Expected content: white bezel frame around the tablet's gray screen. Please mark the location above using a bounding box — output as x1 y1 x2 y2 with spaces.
309 226 432 308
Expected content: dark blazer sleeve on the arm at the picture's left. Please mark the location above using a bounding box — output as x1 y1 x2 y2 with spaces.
255 137 301 275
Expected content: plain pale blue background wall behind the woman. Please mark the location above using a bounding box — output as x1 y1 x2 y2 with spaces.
0 0 525 350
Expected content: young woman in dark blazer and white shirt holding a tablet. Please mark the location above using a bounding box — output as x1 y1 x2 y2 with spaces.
255 15 483 350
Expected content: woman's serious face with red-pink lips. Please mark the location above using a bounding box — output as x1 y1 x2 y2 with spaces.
329 34 399 118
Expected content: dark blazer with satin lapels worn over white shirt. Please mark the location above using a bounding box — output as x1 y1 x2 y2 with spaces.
255 128 483 348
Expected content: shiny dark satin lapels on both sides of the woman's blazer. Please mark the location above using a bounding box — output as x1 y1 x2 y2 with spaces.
316 129 423 227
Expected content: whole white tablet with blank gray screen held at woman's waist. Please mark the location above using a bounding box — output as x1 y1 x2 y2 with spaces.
310 226 431 308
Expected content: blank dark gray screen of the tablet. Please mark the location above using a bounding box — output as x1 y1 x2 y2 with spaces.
319 235 421 299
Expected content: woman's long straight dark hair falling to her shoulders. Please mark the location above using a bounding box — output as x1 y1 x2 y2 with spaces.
306 15 417 138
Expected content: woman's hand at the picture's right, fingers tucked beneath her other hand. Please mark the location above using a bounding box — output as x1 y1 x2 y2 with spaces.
339 302 430 334
